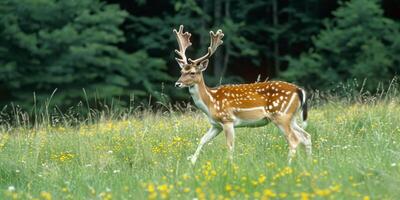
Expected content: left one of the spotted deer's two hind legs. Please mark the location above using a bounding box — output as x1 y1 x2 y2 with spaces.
274 115 301 164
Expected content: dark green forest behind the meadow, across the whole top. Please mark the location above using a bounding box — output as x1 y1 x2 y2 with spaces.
0 0 400 108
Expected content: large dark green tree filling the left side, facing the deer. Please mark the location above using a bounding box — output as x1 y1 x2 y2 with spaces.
0 0 169 106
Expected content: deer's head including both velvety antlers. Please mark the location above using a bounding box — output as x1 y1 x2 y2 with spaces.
174 25 224 88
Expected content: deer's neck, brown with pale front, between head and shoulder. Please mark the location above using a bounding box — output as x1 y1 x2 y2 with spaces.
189 75 215 116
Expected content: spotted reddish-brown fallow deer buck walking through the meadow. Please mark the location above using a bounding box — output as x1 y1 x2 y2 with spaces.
174 25 311 164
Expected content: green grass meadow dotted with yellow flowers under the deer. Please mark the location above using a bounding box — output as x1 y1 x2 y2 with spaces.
0 95 400 199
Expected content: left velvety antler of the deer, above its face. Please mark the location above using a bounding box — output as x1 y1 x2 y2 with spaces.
174 25 192 67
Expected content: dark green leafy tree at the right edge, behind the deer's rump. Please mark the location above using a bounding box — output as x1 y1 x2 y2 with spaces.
283 0 400 90
